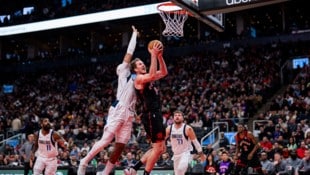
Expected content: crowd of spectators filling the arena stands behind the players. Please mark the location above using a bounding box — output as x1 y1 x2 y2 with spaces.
0 34 310 174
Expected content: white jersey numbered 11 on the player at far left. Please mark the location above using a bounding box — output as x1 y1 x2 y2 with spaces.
36 129 58 158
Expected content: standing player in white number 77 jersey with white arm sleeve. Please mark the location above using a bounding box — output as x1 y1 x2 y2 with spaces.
166 111 206 175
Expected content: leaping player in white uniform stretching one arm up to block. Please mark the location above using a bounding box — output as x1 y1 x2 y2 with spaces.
77 26 138 175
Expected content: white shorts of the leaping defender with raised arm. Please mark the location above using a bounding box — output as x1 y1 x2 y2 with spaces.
104 104 134 144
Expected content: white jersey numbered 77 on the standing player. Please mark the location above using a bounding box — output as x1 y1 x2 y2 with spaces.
170 123 193 155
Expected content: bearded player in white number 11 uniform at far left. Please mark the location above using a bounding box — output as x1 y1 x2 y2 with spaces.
33 118 67 175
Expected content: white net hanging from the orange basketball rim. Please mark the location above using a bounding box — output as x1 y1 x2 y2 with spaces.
159 10 188 37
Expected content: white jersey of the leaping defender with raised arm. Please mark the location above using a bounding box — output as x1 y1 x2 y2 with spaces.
116 62 137 110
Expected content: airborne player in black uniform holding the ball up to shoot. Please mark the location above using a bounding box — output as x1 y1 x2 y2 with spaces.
124 42 168 175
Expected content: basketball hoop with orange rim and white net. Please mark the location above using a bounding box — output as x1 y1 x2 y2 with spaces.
157 2 189 37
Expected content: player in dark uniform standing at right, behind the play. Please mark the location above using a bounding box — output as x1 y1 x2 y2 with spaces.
235 124 263 175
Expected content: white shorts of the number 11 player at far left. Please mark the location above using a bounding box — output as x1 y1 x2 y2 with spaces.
33 157 58 175
